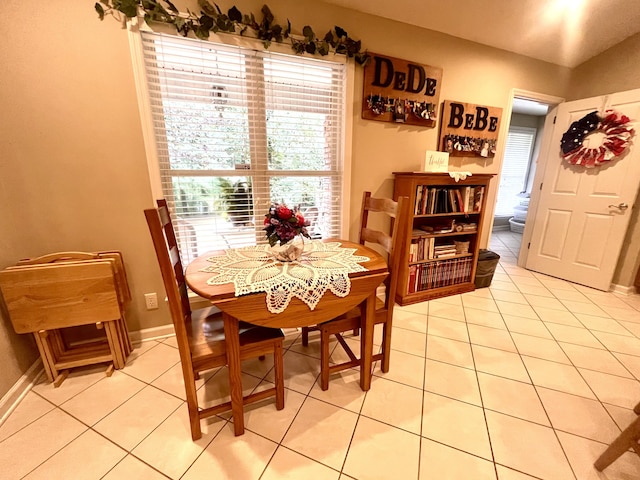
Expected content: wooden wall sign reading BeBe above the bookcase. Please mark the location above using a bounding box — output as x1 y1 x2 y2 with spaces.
439 100 502 157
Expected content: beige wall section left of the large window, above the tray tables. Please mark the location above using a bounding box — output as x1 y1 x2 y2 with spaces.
0 0 169 397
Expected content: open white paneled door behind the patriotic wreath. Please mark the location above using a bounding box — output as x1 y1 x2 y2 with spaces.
526 90 640 290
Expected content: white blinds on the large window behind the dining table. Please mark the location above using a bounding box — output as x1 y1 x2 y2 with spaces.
142 32 346 262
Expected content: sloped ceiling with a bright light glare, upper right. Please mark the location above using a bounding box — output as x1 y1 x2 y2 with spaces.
322 0 640 67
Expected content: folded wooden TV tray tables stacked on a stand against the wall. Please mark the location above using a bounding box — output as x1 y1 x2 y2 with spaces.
0 251 132 387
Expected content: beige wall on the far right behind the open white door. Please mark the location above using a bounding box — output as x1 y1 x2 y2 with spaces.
567 34 640 286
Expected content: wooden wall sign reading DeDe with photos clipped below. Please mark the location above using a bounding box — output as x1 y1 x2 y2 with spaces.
362 52 442 127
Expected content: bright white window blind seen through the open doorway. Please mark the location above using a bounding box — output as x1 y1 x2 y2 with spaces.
494 126 536 217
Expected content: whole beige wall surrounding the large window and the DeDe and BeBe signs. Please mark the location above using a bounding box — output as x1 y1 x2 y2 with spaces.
10 0 640 397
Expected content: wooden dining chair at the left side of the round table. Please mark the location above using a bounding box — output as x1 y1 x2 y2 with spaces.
144 199 284 440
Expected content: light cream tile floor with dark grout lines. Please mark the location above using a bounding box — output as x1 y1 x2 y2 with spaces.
0 232 640 480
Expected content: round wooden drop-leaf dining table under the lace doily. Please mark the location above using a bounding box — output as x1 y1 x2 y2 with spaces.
185 239 389 435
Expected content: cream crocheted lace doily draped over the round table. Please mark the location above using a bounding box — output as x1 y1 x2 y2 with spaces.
202 240 369 313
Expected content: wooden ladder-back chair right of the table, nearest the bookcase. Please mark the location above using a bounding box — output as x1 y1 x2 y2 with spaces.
302 192 409 390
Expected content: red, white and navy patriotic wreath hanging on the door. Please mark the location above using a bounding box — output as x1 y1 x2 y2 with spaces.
560 110 635 168
